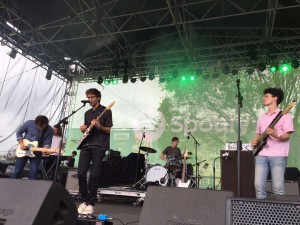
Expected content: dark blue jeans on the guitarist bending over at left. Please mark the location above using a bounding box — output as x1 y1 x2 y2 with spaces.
12 156 42 180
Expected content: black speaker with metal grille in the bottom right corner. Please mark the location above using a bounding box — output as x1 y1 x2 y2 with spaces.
226 196 300 225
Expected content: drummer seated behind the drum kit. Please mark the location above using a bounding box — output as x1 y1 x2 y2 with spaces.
159 137 183 184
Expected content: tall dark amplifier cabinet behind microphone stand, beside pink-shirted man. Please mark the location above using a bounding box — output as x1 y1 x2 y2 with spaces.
220 150 255 198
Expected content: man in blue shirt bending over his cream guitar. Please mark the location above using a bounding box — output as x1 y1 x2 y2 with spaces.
12 115 53 180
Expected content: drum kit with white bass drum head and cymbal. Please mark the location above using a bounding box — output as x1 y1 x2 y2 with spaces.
134 146 192 189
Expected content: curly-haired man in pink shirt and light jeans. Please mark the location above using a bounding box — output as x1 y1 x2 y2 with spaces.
251 88 294 199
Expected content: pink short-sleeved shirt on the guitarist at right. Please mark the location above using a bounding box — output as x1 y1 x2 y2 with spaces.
256 109 294 156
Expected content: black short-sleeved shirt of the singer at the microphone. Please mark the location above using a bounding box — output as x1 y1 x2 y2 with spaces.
82 105 113 151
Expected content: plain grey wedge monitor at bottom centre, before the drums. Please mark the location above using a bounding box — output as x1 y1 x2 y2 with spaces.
139 186 233 225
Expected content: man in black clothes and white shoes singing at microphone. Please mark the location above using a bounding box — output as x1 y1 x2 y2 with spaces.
77 88 113 216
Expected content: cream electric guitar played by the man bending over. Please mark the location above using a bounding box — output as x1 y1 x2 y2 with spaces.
16 139 59 158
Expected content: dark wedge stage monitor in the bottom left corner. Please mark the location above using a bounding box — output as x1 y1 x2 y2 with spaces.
0 178 78 225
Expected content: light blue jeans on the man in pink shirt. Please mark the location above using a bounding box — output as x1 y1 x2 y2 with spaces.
254 155 287 199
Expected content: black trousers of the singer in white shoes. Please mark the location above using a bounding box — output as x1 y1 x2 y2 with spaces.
77 149 105 205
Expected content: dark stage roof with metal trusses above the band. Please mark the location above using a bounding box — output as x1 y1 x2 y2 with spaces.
0 0 300 82
